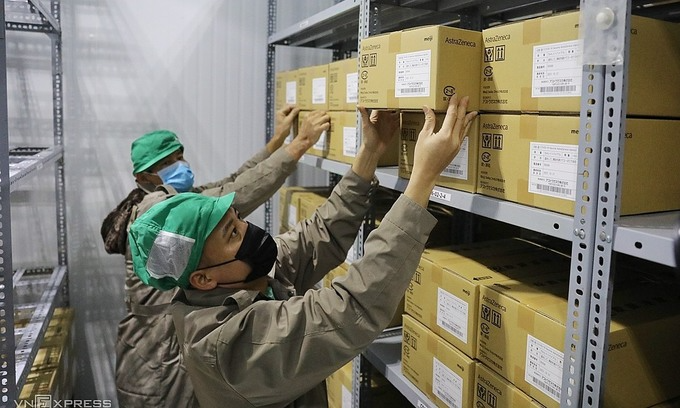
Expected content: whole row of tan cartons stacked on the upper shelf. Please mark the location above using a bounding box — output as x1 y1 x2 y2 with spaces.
277 12 680 215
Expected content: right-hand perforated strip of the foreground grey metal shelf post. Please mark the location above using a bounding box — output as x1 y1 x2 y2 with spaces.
581 0 631 407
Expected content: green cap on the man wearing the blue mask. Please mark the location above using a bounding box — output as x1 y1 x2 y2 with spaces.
130 130 184 174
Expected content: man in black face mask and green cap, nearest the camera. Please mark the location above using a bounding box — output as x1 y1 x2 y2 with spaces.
129 96 476 408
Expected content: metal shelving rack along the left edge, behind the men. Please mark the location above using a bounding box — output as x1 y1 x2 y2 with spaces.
0 0 68 406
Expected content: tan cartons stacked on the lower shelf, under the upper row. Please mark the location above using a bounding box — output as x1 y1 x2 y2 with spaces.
402 239 680 408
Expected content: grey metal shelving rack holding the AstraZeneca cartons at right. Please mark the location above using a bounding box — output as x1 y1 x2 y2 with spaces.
267 0 680 408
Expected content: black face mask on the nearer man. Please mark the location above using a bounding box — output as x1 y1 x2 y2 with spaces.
201 221 278 285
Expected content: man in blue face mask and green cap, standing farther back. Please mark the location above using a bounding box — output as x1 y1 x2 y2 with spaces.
101 107 329 407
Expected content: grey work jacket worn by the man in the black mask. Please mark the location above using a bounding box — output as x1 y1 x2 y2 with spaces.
172 171 436 408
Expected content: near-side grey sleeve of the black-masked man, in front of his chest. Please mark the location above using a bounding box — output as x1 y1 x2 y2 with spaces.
212 196 436 406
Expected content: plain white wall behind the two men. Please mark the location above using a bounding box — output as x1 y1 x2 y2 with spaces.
7 0 333 401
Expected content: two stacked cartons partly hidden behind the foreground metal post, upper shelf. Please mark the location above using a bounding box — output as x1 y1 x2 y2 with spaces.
477 12 680 215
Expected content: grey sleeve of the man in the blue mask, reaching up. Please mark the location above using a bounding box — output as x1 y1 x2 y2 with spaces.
194 149 297 217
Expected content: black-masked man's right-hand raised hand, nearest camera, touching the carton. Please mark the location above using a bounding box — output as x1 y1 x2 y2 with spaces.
404 95 477 207
